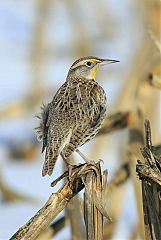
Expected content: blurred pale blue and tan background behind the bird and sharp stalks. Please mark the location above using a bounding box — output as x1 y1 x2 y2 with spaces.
0 0 161 240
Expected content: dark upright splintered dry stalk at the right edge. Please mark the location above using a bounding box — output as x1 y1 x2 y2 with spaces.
136 121 161 240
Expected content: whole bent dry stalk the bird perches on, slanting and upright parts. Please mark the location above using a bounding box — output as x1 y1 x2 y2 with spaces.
10 163 109 240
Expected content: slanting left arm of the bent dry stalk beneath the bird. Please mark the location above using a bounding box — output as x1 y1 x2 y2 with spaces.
10 166 84 240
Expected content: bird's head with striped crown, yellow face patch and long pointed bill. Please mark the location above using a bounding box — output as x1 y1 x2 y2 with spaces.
67 56 119 80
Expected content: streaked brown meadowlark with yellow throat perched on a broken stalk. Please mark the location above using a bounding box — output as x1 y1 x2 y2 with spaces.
36 56 119 176
